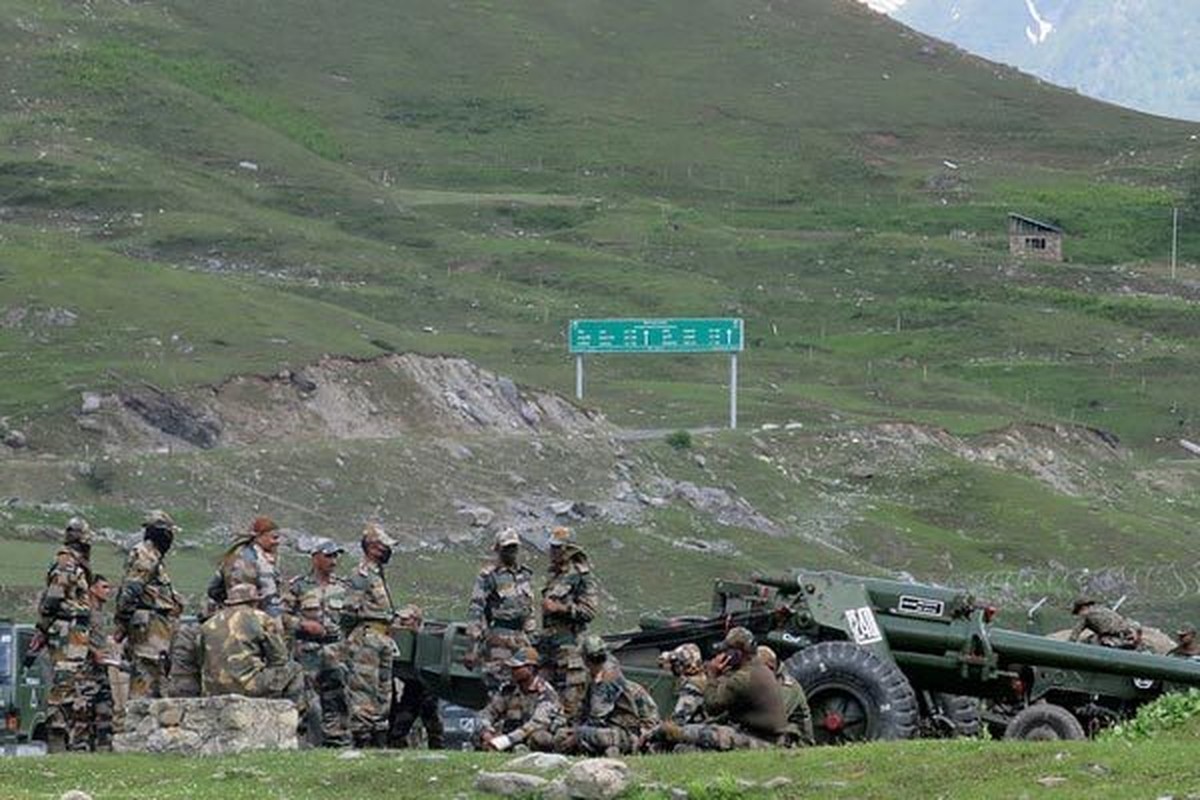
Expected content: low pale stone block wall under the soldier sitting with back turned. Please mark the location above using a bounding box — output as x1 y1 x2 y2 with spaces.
113 694 299 756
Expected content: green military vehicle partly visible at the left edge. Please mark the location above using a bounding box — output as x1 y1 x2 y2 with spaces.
0 619 49 756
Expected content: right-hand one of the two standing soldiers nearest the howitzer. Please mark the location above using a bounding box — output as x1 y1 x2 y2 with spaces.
538 527 596 720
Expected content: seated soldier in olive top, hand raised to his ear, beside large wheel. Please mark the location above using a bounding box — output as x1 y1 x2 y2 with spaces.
668 627 788 750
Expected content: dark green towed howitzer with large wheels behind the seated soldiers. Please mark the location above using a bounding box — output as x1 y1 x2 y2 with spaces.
397 570 1200 744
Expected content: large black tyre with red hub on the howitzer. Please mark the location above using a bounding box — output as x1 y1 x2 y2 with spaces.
786 642 920 745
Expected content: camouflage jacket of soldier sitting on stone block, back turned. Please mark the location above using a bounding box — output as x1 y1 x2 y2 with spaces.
200 604 288 694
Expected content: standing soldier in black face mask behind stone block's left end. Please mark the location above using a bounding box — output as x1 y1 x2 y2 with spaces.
115 511 184 699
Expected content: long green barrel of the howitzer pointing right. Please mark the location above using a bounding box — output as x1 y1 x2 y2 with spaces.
877 614 1200 686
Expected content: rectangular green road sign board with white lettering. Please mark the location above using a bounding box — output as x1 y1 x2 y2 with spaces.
570 318 744 355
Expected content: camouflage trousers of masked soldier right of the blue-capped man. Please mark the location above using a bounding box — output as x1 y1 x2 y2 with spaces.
346 622 396 744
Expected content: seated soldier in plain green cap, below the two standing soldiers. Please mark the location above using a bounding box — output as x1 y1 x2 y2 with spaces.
556 634 660 756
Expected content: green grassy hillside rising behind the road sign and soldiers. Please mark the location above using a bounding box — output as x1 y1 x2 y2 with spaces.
0 0 1200 624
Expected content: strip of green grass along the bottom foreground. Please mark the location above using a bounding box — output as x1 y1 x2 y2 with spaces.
0 739 1200 800
